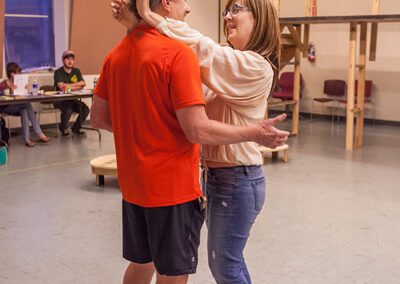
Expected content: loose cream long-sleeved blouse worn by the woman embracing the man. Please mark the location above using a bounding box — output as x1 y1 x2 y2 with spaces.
157 18 274 165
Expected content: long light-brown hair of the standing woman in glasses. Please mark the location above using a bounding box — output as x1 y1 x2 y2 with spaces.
224 0 281 94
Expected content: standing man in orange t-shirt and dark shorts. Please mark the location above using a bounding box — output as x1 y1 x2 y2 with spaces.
91 0 284 283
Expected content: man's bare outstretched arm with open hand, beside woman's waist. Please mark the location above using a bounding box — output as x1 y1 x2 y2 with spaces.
176 105 289 148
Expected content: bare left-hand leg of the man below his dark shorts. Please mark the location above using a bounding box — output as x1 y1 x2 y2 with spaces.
123 262 155 284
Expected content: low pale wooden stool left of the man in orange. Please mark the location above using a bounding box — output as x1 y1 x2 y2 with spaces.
90 154 117 186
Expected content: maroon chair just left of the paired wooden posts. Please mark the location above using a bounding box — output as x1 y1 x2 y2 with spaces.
311 80 346 122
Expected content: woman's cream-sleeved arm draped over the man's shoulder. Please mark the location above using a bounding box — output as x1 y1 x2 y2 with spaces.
120 0 274 107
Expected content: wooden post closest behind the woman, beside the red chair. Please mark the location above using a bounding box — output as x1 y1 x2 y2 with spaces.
292 26 301 135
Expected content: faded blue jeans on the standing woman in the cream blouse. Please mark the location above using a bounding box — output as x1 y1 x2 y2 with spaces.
205 166 265 284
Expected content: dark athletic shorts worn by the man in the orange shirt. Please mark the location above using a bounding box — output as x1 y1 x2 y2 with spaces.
122 199 205 276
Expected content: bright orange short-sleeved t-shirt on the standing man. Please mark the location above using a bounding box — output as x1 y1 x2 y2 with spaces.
95 26 204 207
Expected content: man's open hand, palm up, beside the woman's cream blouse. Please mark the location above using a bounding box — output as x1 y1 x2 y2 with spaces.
256 114 289 149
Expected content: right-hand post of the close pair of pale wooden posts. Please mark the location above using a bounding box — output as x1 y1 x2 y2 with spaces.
356 23 368 148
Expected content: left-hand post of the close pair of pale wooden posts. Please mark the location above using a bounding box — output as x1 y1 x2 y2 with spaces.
346 23 357 150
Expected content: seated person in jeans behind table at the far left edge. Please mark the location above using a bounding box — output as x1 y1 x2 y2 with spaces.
0 62 50 147
